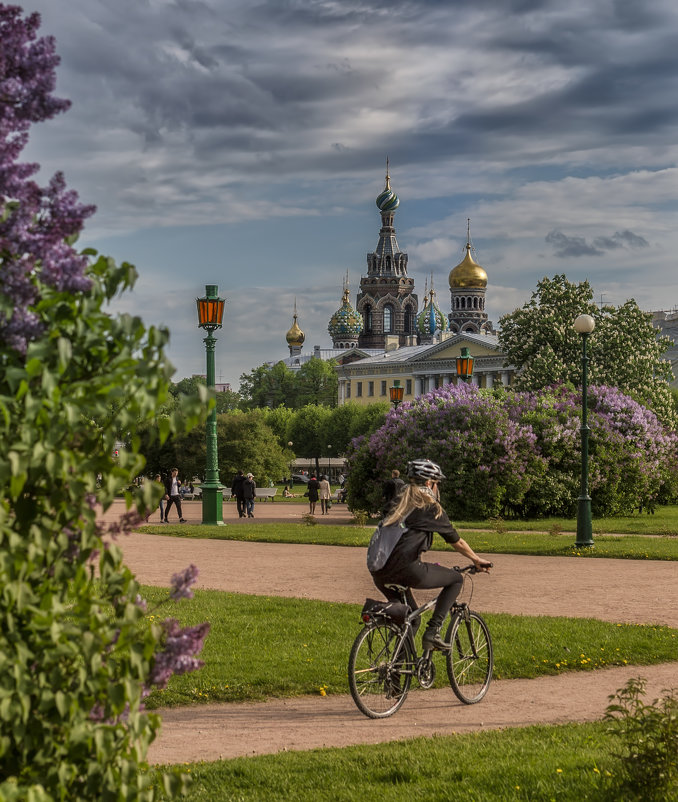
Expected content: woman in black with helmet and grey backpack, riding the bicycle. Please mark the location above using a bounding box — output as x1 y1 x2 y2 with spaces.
372 459 492 650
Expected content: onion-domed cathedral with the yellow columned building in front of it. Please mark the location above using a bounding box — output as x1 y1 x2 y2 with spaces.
270 165 514 404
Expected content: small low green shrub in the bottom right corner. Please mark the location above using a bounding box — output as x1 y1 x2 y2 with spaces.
605 677 678 802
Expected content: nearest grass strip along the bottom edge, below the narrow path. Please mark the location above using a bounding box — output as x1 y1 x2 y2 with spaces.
162 723 652 802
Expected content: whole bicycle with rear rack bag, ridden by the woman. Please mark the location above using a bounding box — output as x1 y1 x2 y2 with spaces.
348 565 494 718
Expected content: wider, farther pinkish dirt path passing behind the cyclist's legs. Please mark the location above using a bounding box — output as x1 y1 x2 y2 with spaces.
120 534 678 627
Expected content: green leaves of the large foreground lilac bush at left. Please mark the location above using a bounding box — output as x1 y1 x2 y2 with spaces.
0 252 199 800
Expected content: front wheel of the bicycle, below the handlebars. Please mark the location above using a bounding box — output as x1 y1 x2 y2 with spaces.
445 612 494 705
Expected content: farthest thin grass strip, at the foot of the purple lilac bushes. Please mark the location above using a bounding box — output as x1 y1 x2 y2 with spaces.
139 522 678 560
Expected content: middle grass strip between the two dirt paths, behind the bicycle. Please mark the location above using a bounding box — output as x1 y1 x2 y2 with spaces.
143 587 678 708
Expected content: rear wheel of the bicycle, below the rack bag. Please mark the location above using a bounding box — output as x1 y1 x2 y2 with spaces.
348 622 414 718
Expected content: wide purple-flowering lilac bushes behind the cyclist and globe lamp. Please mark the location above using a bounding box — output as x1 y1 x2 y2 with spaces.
349 385 678 520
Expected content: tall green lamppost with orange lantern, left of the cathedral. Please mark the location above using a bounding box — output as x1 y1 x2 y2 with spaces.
195 284 224 526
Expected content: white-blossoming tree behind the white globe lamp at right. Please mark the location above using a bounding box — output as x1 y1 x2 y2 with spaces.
499 275 678 424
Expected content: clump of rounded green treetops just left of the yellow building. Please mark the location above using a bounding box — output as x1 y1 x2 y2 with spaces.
240 357 338 409
